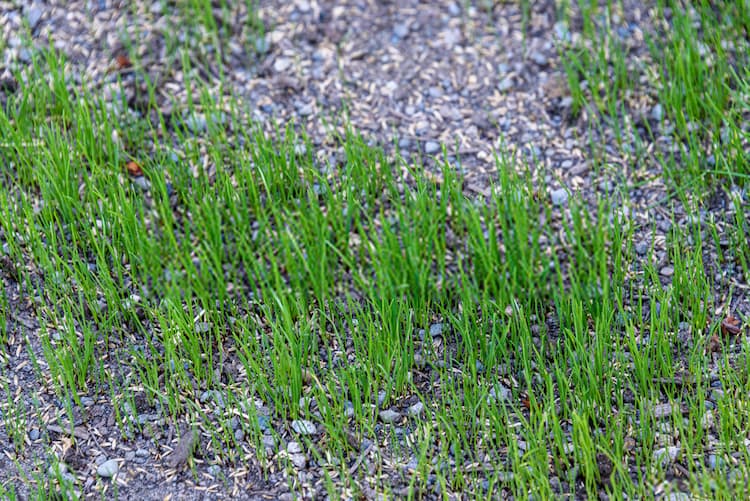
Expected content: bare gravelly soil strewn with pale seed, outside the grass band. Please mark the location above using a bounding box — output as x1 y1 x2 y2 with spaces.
0 0 750 500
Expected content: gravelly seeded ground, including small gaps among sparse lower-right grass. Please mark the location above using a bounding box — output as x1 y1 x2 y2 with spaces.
0 0 750 499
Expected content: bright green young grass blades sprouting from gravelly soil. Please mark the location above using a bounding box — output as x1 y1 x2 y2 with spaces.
0 1 750 499
